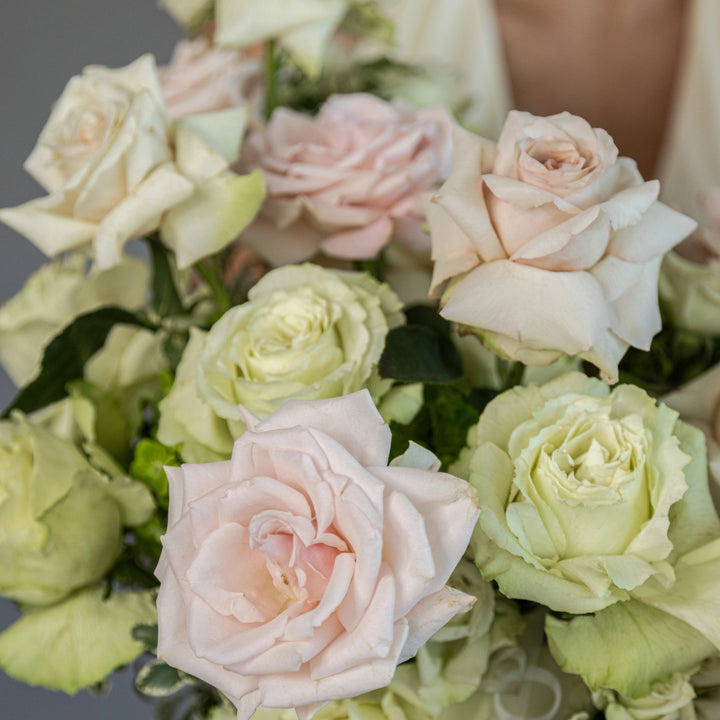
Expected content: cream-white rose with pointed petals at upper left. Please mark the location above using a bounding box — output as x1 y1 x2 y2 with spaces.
0 55 263 268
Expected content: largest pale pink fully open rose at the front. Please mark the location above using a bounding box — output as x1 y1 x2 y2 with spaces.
156 390 479 720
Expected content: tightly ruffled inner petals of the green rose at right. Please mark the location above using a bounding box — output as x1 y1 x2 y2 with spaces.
508 399 652 560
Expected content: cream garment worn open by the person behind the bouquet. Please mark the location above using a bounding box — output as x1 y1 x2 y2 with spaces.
390 0 720 221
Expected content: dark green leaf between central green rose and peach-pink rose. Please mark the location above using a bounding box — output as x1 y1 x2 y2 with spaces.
378 325 463 383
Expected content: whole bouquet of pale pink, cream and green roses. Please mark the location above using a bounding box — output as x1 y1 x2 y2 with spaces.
0 0 720 720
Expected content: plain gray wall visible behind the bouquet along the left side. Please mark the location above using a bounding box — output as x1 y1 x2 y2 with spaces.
0 0 182 720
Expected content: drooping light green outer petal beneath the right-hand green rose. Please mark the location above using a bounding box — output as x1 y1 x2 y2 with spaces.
545 600 715 698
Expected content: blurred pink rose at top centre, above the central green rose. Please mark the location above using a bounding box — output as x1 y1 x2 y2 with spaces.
242 93 452 266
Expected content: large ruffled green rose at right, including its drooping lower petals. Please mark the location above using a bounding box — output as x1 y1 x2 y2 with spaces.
452 373 720 698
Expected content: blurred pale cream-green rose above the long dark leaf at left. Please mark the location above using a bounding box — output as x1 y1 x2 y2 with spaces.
0 255 150 386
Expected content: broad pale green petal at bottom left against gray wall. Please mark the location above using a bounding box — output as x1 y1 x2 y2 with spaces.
0 587 156 694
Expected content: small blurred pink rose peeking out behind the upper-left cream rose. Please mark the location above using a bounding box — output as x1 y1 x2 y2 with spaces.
158 36 262 120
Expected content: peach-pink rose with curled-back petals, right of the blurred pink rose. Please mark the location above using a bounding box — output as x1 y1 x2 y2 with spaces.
428 111 696 382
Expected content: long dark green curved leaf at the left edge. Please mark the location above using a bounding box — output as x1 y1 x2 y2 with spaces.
3 306 151 418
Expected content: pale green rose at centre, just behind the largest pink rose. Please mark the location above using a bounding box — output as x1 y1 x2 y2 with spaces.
158 264 402 462
